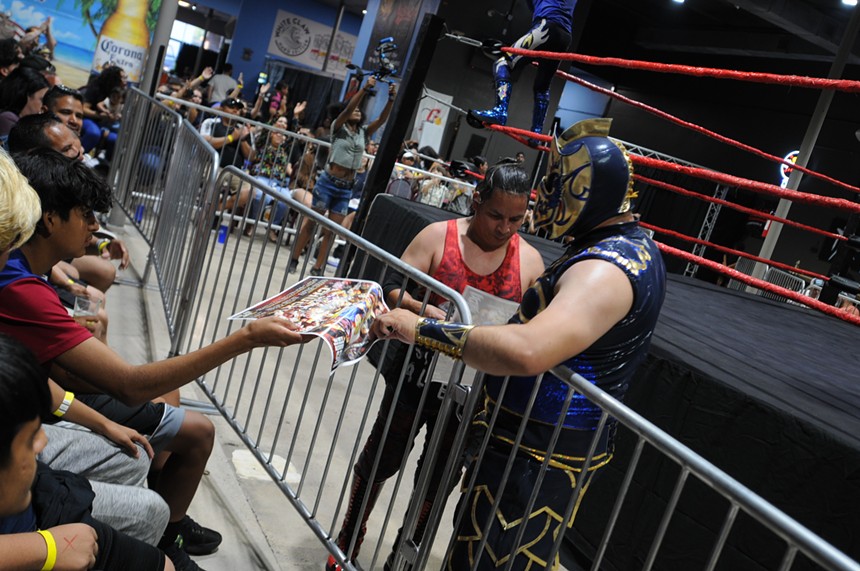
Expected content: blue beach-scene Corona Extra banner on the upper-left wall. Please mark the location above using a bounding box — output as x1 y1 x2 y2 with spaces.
0 0 156 88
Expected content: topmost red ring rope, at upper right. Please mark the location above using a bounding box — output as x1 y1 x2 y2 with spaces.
502 48 860 93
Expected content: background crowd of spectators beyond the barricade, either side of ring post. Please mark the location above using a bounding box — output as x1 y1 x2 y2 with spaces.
153 64 524 275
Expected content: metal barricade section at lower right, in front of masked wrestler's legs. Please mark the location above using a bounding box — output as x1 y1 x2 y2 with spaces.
414 367 860 571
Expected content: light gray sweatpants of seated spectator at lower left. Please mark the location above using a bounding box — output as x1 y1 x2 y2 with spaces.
39 422 170 545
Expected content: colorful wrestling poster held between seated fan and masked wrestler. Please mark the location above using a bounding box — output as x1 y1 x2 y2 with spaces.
229 277 388 371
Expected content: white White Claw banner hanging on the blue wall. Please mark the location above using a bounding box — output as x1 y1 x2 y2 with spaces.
268 10 358 79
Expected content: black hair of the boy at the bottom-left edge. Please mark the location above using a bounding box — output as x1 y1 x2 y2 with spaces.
0 333 51 467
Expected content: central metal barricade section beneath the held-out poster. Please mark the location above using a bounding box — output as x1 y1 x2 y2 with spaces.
174 168 471 570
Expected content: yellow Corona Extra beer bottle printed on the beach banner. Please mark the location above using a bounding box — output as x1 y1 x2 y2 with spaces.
91 0 149 84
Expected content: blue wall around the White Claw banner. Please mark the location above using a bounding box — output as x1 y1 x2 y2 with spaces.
227 0 362 99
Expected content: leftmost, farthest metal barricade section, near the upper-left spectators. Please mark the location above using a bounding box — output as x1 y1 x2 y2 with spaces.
108 89 182 245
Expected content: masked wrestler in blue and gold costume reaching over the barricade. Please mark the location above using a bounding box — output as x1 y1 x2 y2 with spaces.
374 119 665 569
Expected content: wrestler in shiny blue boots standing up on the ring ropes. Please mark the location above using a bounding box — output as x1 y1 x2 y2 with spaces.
467 0 576 143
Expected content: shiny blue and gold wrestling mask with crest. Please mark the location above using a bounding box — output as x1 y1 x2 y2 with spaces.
535 119 633 238
